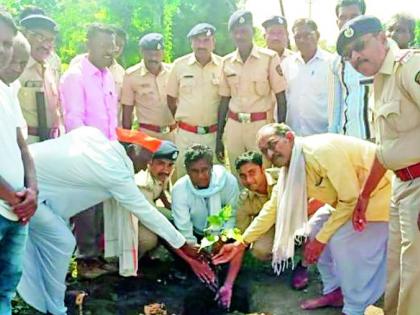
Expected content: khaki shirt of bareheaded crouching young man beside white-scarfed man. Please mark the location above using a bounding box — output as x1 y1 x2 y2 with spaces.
236 168 279 232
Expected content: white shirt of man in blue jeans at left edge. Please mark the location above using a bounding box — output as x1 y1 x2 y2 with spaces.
0 80 25 221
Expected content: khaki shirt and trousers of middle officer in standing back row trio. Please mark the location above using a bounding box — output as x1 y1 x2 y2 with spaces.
167 53 222 178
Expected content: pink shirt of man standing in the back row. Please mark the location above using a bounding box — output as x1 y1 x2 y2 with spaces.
60 56 118 140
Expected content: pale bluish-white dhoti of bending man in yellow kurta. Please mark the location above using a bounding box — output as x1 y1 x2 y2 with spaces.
309 206 388 315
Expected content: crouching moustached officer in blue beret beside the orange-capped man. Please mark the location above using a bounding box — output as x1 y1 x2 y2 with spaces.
135 141 178 259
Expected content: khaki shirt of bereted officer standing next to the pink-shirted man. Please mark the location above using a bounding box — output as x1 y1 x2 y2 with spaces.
121 61 175 126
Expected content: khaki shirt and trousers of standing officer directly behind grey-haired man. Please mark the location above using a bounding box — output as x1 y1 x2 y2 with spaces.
219 46 286 170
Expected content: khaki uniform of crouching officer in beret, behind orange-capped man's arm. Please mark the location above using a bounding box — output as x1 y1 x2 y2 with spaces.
135 170 172 259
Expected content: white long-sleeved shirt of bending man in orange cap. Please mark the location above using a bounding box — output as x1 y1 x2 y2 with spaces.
29 126 185 248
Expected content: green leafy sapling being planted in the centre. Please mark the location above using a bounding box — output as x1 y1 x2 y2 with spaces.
200 205 242 250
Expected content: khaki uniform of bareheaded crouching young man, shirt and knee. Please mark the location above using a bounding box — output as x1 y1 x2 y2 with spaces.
236 168 279 260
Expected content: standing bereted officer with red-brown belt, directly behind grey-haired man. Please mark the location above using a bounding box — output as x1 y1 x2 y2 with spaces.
216 10 286 170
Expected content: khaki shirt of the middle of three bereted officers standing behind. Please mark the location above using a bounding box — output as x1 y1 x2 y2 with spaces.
167 53 222 126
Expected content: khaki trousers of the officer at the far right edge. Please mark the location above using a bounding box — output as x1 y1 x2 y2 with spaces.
384 178 420 315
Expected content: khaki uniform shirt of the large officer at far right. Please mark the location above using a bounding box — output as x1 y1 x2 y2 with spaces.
373 40 420 170
